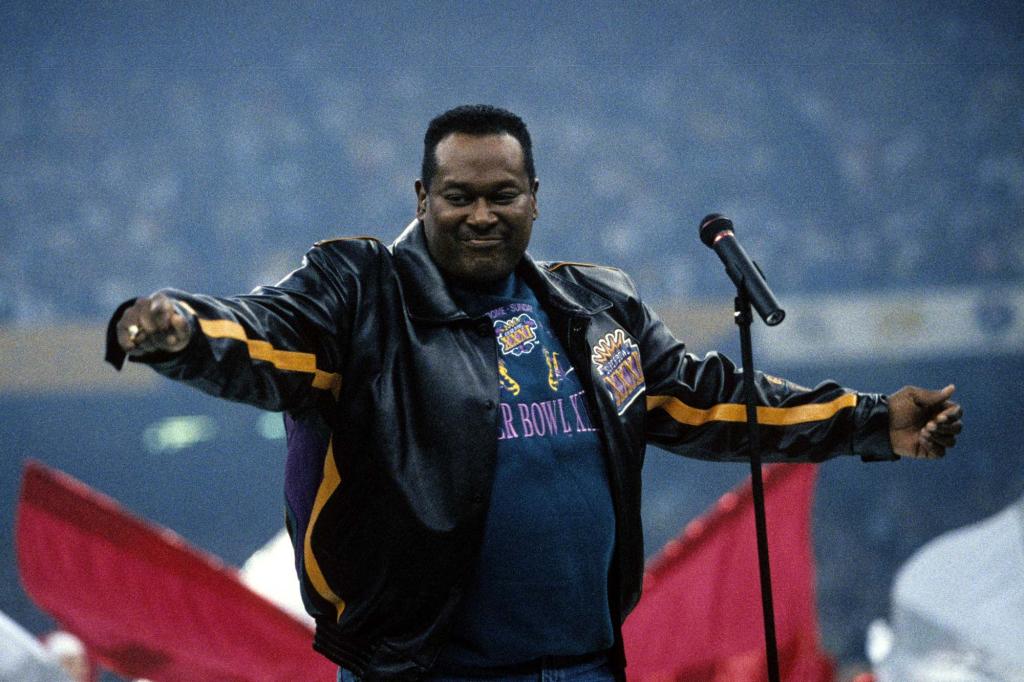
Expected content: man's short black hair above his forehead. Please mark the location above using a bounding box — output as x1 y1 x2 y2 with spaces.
420 104 537 189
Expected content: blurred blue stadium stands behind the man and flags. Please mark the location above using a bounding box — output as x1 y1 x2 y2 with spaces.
0 1 1024 660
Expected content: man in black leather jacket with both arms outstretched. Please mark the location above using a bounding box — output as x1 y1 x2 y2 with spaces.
108 105 961 679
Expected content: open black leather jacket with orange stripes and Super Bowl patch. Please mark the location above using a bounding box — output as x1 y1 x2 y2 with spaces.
108 222 894 679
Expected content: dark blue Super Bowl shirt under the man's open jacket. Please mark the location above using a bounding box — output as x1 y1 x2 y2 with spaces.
438 276 615 669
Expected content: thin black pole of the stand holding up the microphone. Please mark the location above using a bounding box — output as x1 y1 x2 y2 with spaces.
734 288 779 682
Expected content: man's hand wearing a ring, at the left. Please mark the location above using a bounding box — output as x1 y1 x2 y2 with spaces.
117 294 193 355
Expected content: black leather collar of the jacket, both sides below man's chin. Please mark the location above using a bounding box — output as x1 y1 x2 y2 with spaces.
389 219 611 323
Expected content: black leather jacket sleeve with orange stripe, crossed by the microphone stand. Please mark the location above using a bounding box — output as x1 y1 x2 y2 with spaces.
633 284 898 462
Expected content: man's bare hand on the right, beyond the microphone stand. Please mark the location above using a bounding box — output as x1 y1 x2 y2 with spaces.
889 384 964 460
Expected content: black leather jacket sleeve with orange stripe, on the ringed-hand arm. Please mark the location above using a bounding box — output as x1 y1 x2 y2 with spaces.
106 242 358 411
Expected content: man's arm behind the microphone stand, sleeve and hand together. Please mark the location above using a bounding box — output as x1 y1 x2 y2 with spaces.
640 286 964 461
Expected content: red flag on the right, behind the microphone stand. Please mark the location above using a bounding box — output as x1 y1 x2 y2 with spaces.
623 464 835 682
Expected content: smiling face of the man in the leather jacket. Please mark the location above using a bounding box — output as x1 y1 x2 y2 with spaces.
416 133 538 282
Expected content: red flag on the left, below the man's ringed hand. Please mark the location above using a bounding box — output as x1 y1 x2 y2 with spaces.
15 463 337 682
